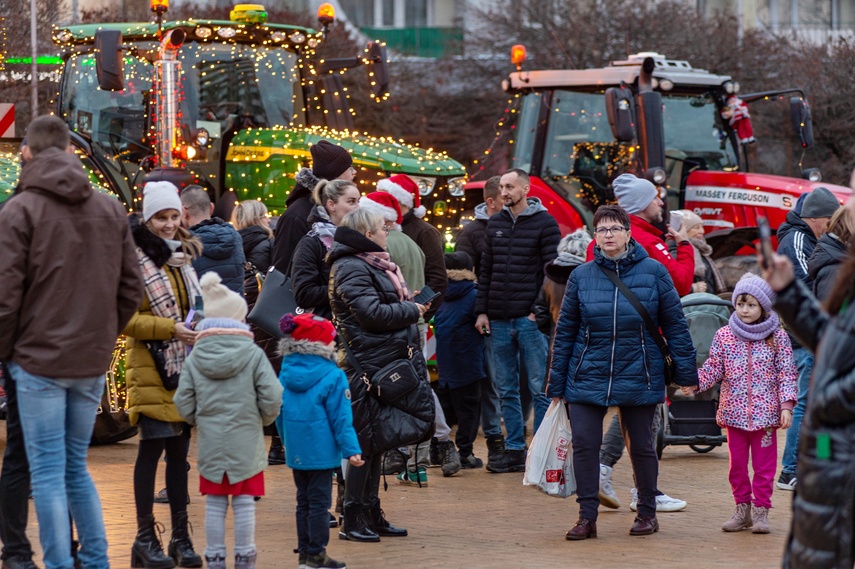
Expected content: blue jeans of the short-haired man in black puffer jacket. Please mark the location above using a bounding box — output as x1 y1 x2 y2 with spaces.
490 317 549 450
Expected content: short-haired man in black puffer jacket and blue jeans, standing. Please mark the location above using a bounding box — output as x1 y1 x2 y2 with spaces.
475 168 561 472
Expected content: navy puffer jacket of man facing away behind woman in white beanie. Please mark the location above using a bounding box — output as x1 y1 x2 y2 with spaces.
190 217 246 296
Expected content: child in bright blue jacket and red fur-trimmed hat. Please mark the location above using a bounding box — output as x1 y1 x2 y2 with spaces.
276 314 365 569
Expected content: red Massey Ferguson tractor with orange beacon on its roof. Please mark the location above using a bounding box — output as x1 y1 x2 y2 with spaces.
467 46 851 254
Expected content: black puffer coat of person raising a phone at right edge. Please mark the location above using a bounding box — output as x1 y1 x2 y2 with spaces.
775 280 855 569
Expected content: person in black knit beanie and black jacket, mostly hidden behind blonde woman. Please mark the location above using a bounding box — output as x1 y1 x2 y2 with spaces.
273 140 356 275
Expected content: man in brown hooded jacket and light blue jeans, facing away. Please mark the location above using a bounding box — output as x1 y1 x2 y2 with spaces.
0 116 142 569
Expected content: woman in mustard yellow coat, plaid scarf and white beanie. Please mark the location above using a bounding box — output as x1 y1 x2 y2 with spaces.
124 182 202 569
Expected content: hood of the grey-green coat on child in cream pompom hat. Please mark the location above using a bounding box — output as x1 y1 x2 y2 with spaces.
190 330 255 379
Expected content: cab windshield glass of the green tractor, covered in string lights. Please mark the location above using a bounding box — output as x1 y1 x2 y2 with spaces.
60 41 305 202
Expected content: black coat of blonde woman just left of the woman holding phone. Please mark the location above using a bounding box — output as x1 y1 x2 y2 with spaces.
291 205 332 319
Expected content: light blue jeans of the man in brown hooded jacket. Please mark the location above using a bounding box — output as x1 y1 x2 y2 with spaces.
8 362 110 569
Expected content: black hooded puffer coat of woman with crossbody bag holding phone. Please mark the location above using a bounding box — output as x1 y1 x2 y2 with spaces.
327 227 436 457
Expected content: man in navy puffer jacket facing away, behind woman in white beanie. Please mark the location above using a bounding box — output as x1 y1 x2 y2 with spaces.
181 186 246 296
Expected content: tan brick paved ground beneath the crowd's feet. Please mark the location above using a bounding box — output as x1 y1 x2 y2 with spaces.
5 414 792 569
